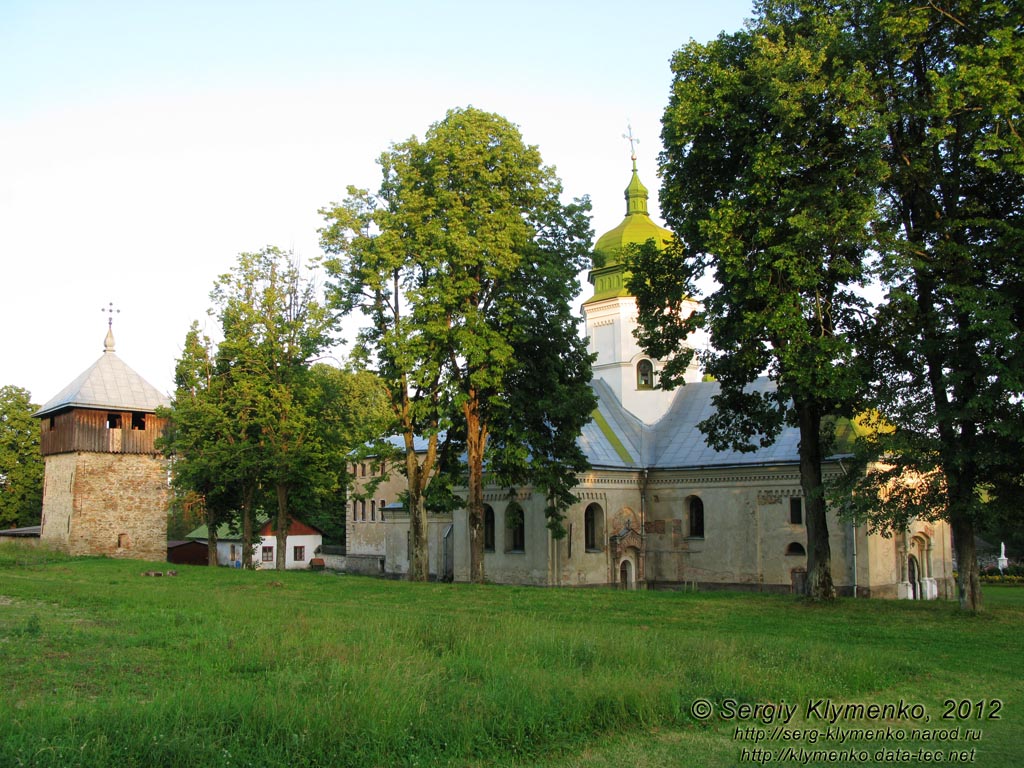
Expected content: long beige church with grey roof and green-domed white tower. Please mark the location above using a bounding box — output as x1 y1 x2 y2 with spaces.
346 160 953 599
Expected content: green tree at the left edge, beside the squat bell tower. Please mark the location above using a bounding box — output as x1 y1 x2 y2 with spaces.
0 385 43 528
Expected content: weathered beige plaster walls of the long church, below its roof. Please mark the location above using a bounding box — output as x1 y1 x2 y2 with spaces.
349 465 952 597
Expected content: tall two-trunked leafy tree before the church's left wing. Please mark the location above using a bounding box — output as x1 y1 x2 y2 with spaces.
325 108 591 582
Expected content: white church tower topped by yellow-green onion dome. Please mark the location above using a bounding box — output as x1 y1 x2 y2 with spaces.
583 155 700 424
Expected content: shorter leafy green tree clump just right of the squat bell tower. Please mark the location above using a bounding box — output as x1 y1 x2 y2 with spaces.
162 248 390 568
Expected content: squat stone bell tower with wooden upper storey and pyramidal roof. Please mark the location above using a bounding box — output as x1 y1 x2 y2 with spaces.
35 328 170 560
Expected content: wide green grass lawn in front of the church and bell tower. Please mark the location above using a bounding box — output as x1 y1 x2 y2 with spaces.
0 547 1024 768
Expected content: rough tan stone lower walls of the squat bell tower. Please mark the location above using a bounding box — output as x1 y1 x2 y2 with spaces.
42 453 169 561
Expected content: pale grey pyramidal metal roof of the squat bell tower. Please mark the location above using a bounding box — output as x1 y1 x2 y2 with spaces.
35 331 171 417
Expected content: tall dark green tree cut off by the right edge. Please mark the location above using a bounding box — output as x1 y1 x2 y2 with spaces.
831 0 1024 610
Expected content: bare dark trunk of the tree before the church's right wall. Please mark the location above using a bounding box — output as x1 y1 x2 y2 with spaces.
797 402 836 600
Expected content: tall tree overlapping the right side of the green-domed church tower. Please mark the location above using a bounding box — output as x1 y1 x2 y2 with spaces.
630 1 879 599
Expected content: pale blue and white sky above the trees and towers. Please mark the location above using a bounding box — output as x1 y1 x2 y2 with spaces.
0 0 753 404
